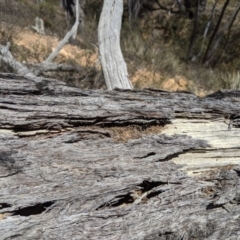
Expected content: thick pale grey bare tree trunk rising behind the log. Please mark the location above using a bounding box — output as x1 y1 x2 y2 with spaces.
98 0 133 90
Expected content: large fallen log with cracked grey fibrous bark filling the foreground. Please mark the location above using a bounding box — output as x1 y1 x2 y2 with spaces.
0 74 240 240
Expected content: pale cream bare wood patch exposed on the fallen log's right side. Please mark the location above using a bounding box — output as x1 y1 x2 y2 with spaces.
162 119 240 174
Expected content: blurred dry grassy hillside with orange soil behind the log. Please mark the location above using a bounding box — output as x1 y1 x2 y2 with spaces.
0 0 240 95
